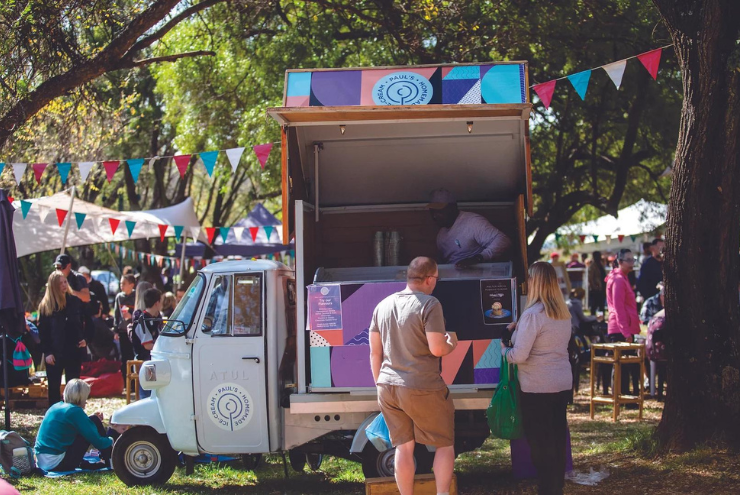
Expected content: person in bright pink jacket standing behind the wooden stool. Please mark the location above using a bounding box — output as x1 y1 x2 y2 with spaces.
606 249 640 395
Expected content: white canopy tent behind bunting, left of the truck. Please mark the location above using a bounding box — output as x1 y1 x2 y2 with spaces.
13 190 206 257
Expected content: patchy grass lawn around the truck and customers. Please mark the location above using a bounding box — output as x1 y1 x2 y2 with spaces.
5 383 740 495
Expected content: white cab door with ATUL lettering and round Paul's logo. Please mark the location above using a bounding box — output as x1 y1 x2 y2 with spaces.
193 273 270 454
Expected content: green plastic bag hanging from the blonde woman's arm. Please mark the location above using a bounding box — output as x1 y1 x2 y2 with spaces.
486 354 524 440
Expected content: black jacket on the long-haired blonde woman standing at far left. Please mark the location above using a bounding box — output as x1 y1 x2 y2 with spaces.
39 294 84 361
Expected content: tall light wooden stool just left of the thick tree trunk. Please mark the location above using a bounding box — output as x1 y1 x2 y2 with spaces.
591 342 645 421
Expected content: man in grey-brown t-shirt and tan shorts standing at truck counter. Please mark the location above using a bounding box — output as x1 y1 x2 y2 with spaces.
370 257 457 495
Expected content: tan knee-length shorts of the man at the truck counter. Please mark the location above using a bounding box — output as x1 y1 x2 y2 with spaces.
378 383 455 447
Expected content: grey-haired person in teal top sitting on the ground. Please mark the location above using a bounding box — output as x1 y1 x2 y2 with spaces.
34 378 113 472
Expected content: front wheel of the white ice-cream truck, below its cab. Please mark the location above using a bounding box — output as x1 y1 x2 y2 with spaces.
113 426 177 486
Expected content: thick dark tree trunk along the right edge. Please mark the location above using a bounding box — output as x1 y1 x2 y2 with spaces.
654 0 740 449
